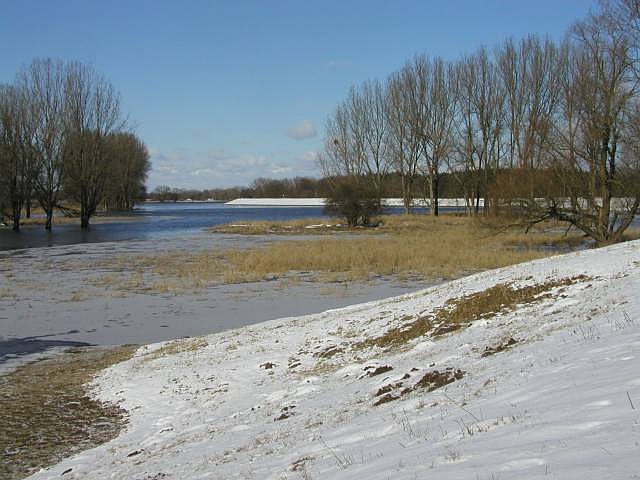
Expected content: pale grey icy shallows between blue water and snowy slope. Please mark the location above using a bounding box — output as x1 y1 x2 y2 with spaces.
0 233 428 363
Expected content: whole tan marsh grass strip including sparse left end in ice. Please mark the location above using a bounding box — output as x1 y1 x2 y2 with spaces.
89 215 616 292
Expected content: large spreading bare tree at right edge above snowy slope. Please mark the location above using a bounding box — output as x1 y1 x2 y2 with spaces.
529 11 640 245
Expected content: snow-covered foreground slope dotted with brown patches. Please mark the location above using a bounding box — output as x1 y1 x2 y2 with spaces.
32 242 640 480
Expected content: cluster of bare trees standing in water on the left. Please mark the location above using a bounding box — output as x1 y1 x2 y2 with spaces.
0 59 150 231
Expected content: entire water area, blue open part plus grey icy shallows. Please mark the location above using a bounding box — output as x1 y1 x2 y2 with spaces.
0 203 433 368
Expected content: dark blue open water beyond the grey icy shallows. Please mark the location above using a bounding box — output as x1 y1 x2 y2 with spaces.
0 203 326 250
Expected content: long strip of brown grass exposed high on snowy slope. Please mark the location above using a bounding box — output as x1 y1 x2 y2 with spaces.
354 276 588 350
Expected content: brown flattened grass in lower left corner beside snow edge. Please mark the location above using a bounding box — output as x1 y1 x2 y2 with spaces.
0 346 135 480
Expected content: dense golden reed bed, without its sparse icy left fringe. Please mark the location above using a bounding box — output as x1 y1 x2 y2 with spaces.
210 216 581 281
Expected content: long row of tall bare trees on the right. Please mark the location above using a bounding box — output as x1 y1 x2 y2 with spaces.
320 0 640 244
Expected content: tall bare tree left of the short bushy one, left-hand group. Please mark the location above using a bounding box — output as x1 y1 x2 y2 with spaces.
64 63 123 228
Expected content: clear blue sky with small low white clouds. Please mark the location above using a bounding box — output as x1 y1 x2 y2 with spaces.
0 0 595 188
